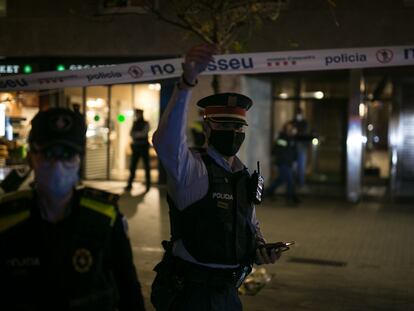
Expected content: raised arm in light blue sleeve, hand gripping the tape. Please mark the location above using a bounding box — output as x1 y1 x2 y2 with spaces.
153 44 215 207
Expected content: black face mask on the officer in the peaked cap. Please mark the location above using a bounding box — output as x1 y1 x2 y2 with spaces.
209 130 245 157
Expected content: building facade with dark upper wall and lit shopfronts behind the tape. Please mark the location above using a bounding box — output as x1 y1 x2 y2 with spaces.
0 0 414 202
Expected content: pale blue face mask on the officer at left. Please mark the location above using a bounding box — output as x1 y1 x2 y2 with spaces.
36 161 79 198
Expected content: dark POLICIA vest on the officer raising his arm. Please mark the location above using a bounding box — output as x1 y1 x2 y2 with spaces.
168 154 256 265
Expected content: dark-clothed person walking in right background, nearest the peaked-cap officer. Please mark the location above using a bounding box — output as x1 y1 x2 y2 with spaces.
266 122 299 203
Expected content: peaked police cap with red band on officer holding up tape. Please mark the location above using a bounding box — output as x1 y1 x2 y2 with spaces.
197 93 253 125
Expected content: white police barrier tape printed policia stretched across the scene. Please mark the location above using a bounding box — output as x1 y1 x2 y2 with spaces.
0 45 414 91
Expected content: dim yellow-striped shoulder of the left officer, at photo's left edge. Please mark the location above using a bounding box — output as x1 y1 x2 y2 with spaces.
0 190 33 233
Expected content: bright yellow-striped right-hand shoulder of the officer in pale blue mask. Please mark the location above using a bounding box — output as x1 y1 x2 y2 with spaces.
80 187 119 226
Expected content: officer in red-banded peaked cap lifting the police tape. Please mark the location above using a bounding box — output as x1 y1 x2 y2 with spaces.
151 45 280 311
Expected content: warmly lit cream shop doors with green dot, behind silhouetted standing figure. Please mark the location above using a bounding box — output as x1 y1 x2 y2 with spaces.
63 83 161 180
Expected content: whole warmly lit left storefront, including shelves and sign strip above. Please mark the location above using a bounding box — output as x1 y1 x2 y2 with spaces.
0 58 171 186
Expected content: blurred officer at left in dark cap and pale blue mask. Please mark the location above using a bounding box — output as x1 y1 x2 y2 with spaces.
0 108 144 311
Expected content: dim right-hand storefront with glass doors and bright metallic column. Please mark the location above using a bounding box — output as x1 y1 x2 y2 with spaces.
262 67 414 201
